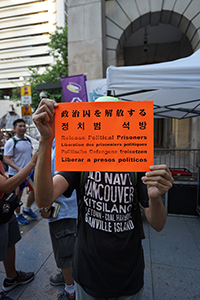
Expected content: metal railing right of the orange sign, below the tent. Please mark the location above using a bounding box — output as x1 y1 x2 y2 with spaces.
154 149 200 177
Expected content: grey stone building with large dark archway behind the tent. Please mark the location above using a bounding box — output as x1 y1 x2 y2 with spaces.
68 0 200 148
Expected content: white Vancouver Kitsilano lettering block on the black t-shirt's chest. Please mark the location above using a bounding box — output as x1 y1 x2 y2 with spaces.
84 172 138 232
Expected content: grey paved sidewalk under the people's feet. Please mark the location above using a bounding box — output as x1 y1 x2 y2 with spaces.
0 194 200 300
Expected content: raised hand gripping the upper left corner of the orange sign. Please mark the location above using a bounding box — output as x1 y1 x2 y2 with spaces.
33 99 58 140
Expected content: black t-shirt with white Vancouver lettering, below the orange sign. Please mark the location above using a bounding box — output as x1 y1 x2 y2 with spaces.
59 172 148 298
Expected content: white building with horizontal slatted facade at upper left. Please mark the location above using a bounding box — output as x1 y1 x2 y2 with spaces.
0 0 67 92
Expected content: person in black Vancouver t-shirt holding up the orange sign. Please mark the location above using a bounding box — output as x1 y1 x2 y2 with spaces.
33 97 173 300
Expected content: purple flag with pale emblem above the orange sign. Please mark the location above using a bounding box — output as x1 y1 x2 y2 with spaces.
61 75 88 102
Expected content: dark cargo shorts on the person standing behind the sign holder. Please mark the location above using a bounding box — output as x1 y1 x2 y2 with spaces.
49 219 76 269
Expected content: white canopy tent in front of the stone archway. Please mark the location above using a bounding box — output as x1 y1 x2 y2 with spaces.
106 50 200 119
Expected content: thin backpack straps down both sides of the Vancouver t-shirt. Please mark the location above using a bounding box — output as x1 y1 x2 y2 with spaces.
77 172 145 239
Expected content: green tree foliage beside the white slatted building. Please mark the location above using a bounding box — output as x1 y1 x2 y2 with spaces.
12 27 68 111
